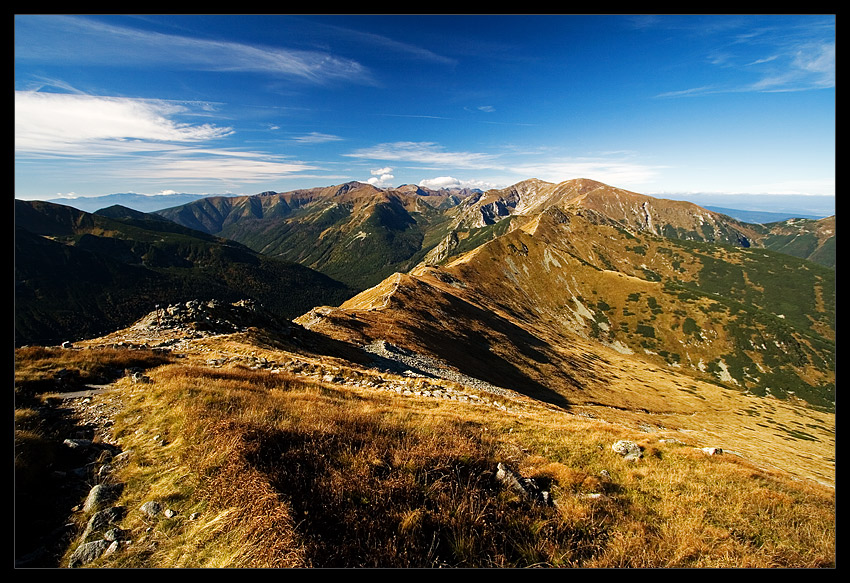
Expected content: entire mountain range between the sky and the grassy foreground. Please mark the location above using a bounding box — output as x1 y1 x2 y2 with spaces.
16 179 835 409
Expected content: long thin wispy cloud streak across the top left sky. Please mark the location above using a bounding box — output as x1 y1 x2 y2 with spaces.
15 15 372 83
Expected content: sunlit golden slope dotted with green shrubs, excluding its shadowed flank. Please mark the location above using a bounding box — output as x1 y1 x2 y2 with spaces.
420 211 836 410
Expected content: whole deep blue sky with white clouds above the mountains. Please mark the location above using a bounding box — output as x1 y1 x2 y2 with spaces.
15 15 835 213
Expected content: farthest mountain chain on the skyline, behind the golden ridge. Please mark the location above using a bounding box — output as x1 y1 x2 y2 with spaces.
158 179 784 289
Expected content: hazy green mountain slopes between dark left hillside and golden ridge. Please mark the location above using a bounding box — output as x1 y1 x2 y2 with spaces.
159 182 458 289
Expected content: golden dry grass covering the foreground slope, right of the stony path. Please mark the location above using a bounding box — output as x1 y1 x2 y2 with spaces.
14 345 835 568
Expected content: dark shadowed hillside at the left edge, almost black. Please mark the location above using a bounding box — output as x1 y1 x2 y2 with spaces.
15 200 354 344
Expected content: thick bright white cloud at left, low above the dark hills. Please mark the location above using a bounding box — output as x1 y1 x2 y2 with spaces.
15 91 322 186
